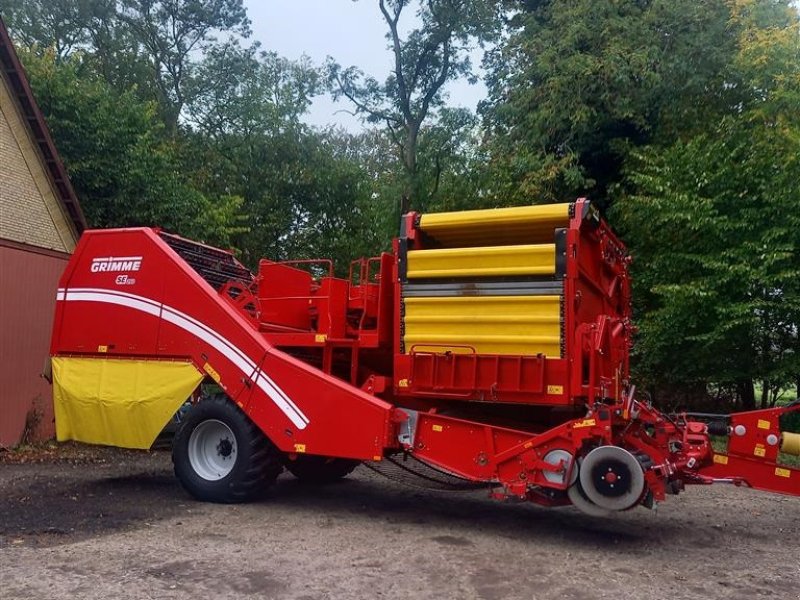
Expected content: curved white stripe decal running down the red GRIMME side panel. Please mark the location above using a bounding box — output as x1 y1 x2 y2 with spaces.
56 288 310 429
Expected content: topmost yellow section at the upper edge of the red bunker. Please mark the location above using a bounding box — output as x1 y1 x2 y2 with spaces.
420 203 570 247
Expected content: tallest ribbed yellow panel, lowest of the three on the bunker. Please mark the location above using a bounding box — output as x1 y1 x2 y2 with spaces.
403 296 561 358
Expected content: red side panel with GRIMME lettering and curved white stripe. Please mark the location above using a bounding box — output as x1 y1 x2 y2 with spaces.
51 228 394 459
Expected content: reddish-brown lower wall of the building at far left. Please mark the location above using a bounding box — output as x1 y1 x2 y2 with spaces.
0 240 69 446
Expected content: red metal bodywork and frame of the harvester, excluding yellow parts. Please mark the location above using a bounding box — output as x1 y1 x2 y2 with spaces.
51 200 800 510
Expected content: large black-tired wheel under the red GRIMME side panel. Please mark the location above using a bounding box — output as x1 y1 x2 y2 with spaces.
172 395 283 503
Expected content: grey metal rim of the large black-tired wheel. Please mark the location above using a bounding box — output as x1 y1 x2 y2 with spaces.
189 419 238 481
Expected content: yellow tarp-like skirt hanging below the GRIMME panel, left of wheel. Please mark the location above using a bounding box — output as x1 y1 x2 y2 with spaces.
52 356 203 449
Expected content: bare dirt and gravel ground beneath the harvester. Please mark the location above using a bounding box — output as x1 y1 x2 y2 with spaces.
0 446 800 600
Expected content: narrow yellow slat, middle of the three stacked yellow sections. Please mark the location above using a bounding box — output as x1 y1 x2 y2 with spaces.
408 244 556 279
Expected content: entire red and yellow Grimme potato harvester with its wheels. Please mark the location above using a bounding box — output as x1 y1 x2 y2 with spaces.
51 200 800 514
